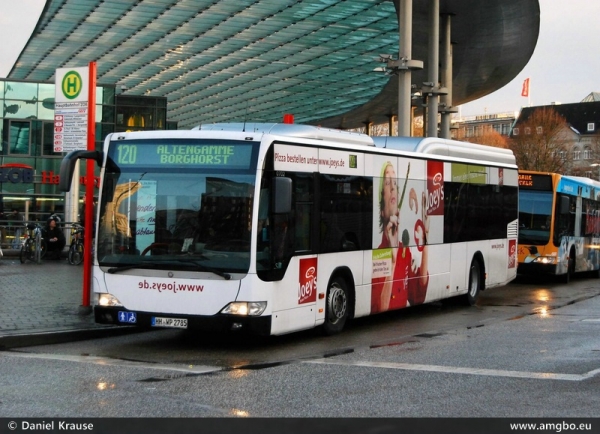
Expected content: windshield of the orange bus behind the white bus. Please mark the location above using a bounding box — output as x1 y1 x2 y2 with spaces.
519 189 552 246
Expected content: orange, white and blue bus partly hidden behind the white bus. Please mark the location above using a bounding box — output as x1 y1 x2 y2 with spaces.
518 171 600 282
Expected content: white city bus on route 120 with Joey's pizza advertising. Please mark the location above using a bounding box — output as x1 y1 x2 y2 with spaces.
60 123 518 335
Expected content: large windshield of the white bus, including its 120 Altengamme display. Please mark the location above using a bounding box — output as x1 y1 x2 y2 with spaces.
97 139 258 274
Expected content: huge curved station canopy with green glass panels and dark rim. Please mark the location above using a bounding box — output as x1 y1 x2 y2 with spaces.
8 0 540 129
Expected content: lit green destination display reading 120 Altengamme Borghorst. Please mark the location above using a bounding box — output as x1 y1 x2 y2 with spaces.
109 141 253 169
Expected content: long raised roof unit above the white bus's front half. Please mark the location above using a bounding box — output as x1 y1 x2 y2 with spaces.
193 122 375 146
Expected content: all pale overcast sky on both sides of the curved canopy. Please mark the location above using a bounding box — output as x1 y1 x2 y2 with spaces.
0 0 600 116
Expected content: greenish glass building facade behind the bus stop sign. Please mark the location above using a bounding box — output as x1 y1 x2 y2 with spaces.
0 80 172 246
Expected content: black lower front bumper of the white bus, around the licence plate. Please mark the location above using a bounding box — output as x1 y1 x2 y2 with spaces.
94 306 271 335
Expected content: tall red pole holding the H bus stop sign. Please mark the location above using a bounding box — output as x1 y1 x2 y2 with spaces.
83 62 96 308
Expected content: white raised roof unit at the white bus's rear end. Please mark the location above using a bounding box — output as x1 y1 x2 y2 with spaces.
373 137 516 165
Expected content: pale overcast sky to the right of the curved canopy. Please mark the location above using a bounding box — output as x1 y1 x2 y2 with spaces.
460 0 600 116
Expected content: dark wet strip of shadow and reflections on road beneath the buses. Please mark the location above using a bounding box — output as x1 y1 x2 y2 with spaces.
15 270 600 372
